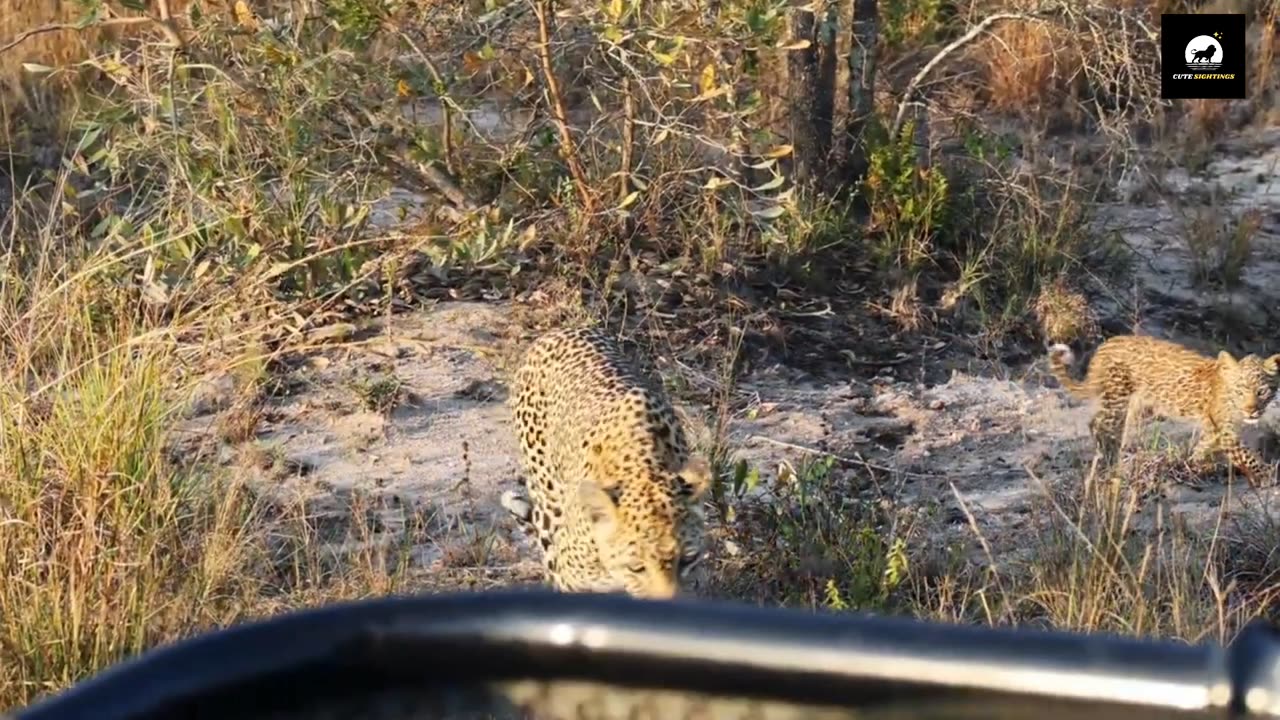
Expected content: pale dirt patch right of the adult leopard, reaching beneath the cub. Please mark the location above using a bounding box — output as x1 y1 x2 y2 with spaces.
731 358 1280 556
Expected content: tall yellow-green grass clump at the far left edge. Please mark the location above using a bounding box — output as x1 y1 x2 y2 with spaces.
0 190 240 707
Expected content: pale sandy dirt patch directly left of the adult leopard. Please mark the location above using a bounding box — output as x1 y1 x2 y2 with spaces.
183 304 536 582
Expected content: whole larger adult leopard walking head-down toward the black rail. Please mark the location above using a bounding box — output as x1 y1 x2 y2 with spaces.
502 329 712 598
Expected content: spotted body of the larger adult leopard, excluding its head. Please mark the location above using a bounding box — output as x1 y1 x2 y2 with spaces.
504 328 700 589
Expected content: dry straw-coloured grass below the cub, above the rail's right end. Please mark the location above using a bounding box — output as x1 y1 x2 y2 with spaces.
909 452 1280 642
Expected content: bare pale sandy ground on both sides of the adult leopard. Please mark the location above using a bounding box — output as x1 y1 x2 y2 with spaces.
175 132 1280 594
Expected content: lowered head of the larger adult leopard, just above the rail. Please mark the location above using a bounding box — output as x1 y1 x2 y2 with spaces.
579 457 712 598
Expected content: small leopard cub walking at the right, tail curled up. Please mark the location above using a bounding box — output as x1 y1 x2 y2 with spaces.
1050 336 1280 487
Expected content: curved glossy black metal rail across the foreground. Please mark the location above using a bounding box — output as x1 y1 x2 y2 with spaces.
12 591 1280 720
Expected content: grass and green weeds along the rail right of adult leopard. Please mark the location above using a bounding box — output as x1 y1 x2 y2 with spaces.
718 435 1280 642
